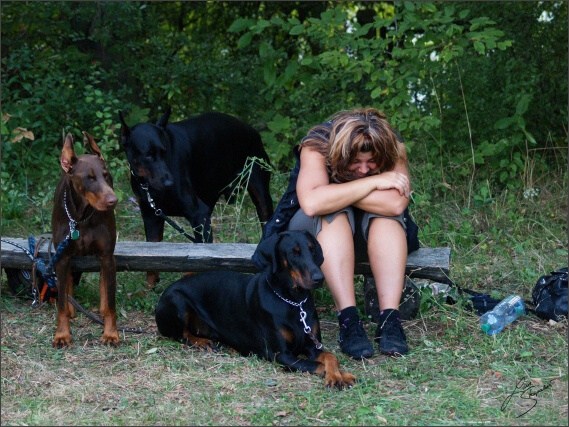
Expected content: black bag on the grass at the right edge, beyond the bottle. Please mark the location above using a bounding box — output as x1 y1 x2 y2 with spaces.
532 267 567 322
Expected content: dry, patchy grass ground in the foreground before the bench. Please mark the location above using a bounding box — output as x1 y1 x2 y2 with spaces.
1 288 567 425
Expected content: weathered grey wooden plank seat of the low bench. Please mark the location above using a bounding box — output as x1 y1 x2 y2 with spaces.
0 237 450 283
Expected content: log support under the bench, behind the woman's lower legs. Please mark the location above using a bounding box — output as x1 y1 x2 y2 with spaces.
364 274 421 323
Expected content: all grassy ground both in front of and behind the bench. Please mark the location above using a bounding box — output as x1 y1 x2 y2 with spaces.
0 158 568 426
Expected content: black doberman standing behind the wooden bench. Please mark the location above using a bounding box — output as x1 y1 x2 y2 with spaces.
119 108 273 288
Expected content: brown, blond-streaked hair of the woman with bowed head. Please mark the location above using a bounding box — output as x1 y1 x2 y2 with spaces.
300 108 400 183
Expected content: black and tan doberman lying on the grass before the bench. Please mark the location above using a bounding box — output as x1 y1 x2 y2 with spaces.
156 231 355 389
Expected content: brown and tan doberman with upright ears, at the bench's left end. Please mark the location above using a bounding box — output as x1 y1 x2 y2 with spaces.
51 132 119 348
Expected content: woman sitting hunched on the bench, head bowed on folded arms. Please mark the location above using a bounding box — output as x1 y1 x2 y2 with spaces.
253 108 419 358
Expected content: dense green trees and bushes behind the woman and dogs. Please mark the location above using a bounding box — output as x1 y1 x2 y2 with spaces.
0 2 567 254
